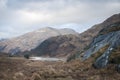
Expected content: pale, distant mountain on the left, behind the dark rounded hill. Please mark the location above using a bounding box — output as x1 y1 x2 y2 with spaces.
0 27 78 54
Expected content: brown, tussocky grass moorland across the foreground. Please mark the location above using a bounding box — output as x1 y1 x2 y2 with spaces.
0 57 120 80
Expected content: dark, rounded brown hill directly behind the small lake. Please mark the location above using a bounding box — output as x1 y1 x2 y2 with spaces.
30 35 82 57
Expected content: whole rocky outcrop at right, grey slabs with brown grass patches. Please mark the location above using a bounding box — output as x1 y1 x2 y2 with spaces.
82 22 120 68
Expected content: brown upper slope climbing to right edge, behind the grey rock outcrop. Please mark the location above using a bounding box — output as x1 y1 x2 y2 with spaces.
79 13 120 48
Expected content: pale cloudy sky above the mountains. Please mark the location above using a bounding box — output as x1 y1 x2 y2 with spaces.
0 0 120 38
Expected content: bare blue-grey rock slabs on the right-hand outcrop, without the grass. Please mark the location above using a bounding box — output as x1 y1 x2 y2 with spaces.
82 23 120 68
